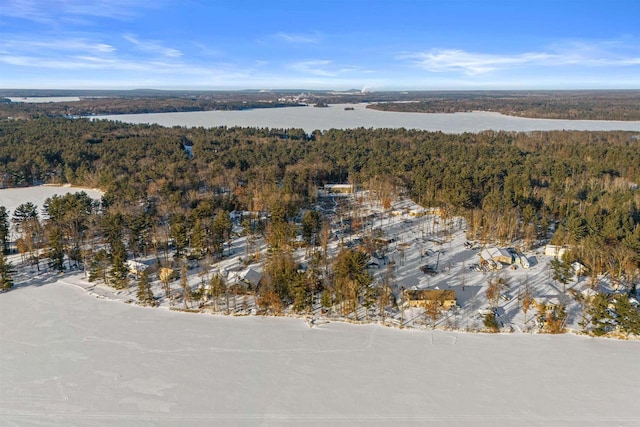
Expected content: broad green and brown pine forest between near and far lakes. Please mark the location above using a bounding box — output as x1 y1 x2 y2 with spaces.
0 117 640 334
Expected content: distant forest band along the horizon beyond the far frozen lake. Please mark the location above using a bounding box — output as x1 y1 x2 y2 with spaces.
5 90 640 120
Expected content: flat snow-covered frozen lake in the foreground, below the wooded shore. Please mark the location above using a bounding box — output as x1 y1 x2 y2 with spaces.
0 280 640 426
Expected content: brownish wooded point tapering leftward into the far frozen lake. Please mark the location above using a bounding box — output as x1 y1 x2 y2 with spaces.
367 91 640 120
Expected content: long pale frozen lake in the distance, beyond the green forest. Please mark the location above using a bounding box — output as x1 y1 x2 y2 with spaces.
95 104 640 133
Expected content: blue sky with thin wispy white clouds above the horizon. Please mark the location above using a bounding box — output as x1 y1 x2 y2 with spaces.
0 0 640 90
